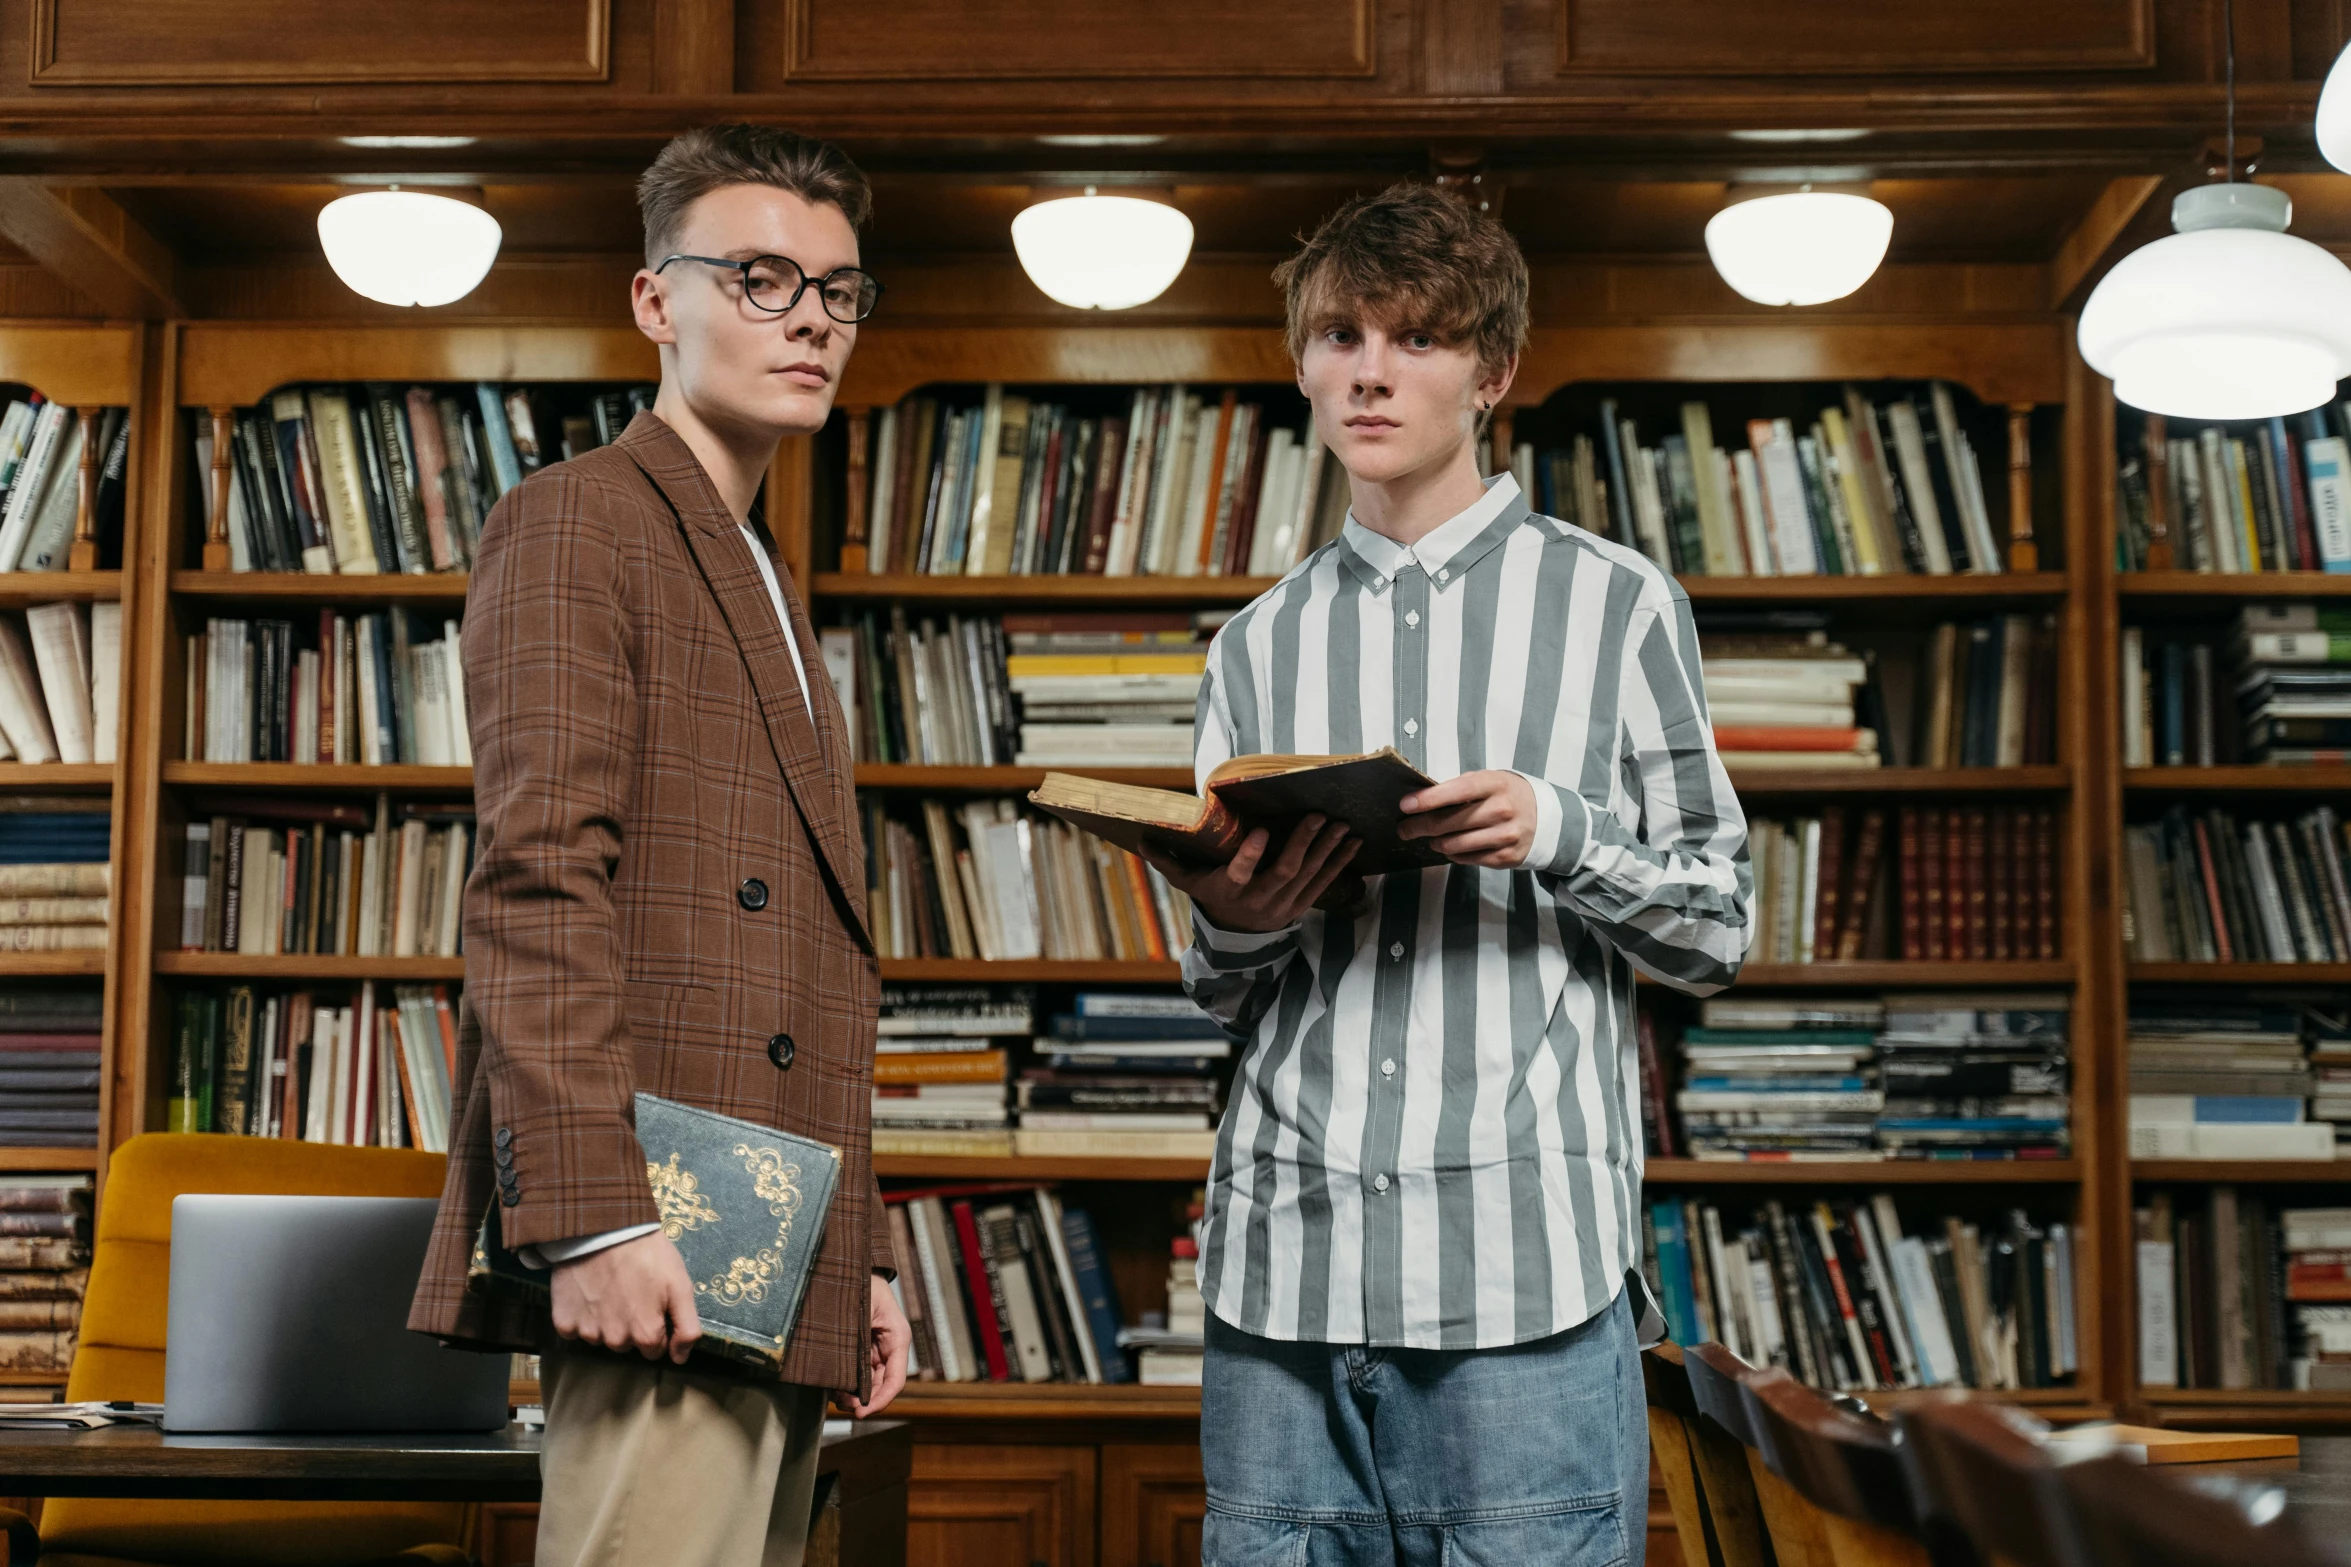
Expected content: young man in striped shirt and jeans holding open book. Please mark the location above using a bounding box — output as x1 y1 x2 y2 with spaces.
1161 186 1751 1567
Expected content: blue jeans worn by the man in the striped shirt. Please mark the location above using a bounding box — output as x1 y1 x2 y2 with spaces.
1199 1292 1648 1567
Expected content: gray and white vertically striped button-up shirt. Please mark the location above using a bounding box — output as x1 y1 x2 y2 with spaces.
1183 475 1754 1349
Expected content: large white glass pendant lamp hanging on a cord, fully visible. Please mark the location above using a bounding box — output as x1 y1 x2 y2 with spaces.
2081 183 2351 418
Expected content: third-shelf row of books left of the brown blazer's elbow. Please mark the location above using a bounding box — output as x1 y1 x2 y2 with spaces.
176 794 475 959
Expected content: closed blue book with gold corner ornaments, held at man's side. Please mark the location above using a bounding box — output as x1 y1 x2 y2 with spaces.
468 1095 842 1370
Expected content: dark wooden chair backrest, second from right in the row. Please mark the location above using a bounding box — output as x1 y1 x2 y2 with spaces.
1895 1400 2095 1567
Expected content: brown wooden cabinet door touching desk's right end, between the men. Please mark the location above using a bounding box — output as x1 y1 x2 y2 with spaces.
905 1442 1096 1567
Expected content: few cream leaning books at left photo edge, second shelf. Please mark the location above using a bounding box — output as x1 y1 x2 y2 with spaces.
0 599 122 764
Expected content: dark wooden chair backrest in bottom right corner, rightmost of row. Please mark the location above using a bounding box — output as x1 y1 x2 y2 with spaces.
2057 1457 2351 1567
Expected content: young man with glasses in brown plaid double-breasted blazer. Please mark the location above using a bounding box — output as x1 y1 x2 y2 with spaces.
409 125 907 1567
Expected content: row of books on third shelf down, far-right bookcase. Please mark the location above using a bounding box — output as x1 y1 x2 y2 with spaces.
2123 806 2351 963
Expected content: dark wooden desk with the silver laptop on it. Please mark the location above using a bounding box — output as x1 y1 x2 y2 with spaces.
0 1419 915 1567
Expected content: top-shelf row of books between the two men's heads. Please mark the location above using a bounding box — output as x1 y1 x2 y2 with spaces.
851 383 1347 576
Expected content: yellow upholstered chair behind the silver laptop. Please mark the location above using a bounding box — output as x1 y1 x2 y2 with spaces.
12 1132 473 1567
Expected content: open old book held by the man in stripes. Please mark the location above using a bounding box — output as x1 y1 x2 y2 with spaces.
1030 747 1446 876
